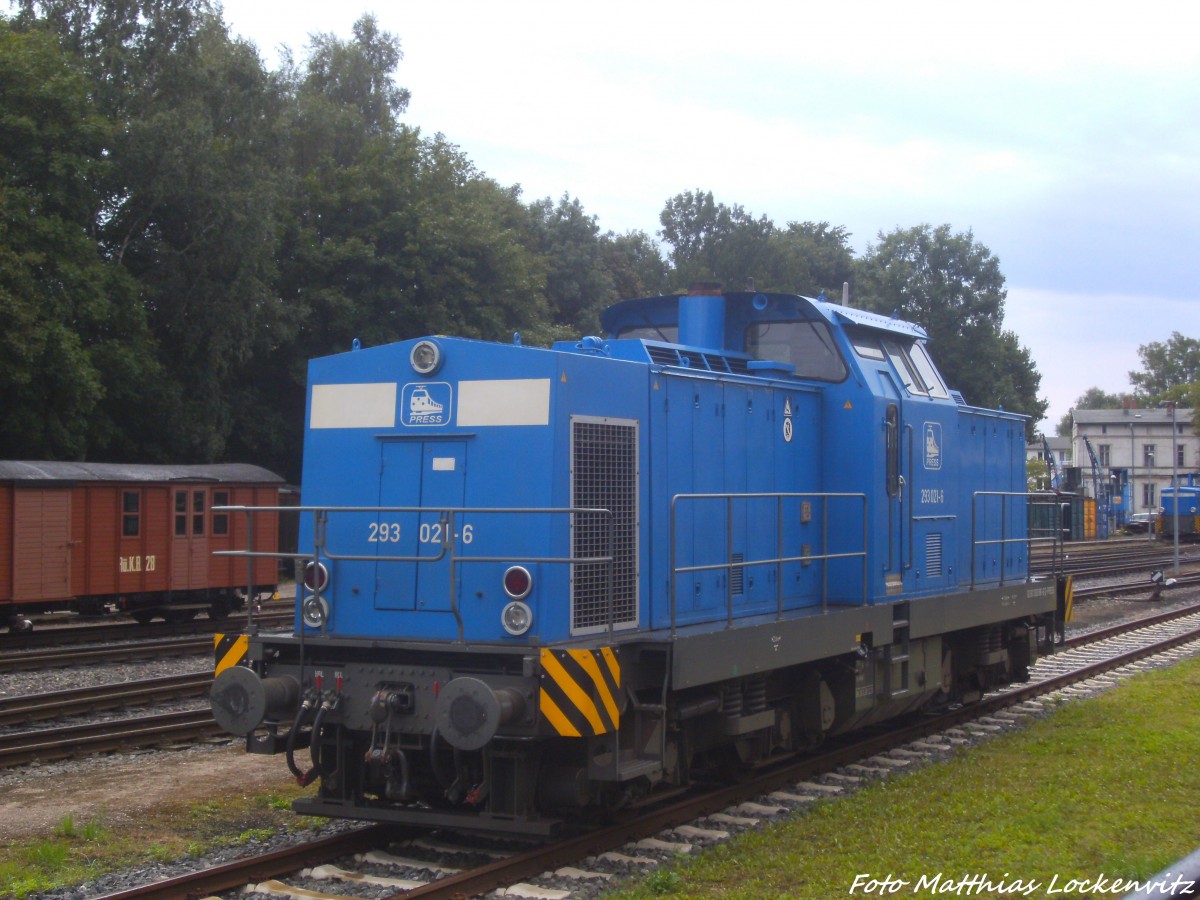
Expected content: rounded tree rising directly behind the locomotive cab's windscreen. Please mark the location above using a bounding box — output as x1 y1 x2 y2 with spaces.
858 224 1048 434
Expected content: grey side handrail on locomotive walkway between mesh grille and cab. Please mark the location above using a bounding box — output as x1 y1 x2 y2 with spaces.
671 492 870 637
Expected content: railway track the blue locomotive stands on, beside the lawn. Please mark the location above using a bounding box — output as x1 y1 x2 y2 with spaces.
79 607 1200 900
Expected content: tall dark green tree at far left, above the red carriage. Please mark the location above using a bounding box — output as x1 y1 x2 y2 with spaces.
0 20 152 458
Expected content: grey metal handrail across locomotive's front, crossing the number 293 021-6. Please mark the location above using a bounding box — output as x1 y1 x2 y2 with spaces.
214 506 614 643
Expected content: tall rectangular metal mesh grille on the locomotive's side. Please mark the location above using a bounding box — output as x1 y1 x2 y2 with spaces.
571 416 637 634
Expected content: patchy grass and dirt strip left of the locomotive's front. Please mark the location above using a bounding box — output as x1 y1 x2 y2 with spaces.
0 787 320 900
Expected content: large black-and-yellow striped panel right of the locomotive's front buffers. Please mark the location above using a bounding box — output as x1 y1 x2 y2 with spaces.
539 647 620 738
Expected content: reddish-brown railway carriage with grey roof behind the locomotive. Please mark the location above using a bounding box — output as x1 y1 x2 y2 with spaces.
0 461 283 629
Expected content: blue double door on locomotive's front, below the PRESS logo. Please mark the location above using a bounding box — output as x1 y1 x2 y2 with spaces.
374 440 467 610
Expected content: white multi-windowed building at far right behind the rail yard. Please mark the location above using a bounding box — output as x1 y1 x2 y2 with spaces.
1070 407 1200 524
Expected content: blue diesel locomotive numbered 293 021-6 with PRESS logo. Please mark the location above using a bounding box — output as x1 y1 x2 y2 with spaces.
211 288 1056 834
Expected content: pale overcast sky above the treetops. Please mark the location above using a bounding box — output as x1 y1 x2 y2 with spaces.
223 0 1200 431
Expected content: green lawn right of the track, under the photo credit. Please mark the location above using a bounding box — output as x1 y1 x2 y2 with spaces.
606 660 1200 900
